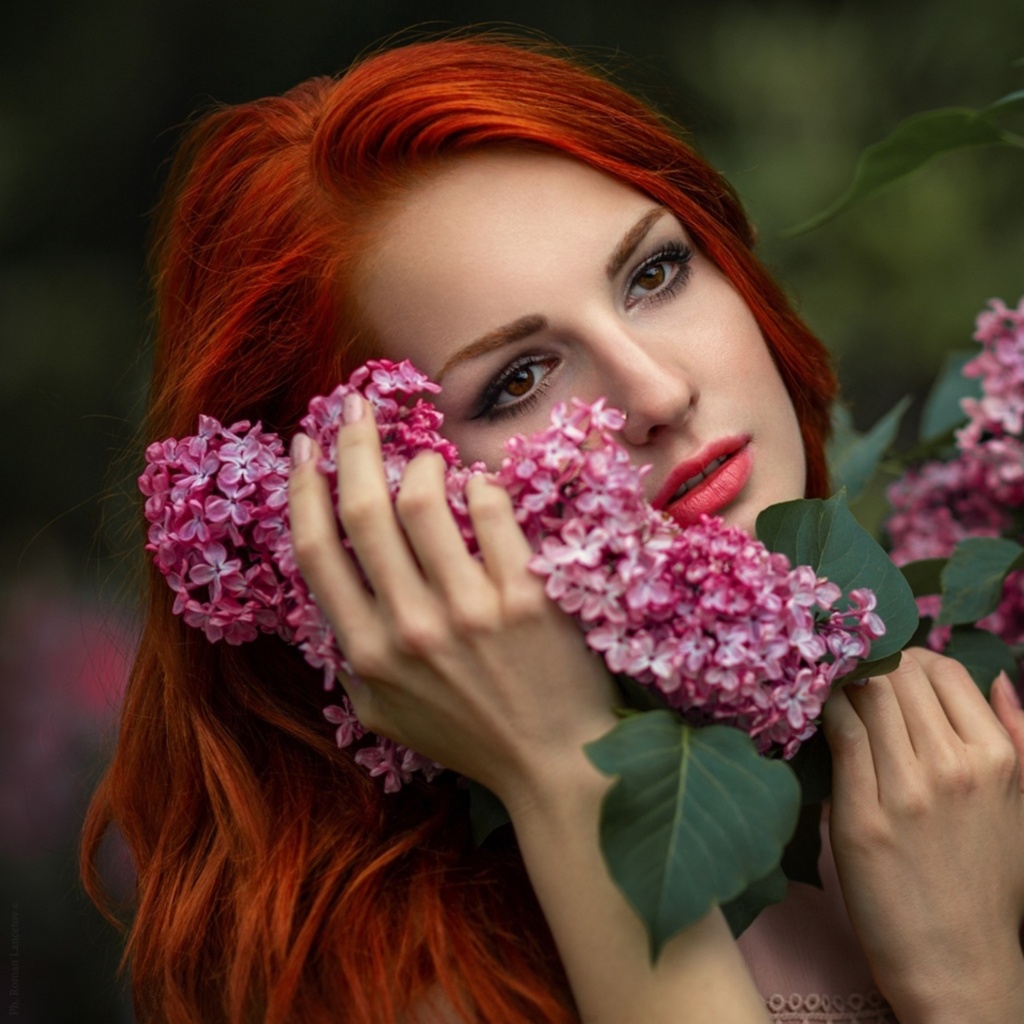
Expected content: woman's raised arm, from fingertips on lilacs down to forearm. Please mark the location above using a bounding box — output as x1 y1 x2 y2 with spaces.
291 397 767 1024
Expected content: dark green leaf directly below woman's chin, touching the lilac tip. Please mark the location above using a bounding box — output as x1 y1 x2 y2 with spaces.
757 493 918 660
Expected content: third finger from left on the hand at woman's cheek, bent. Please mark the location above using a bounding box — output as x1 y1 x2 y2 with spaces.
395 452 486 599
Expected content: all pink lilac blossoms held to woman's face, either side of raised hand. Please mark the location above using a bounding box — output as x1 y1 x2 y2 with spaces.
139 360 885 792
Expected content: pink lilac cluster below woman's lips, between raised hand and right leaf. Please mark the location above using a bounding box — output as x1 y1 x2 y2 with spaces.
491 399 885 757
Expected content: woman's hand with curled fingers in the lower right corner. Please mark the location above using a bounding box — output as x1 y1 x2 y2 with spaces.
825 649 1024 1024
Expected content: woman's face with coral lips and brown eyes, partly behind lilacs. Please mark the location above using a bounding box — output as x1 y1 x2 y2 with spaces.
357 150 805 531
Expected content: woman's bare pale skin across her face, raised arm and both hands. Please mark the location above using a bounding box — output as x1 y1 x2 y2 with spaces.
291 151 1024 1024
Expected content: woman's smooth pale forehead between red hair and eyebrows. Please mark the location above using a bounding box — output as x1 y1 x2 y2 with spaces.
357 148 656 357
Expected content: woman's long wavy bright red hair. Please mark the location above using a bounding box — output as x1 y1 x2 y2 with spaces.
83 37 835 1024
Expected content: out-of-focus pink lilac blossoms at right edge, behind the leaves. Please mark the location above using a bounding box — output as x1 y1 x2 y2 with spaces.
886 299 1024 647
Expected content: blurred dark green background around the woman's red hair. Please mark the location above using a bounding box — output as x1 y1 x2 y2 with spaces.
0 0 1024 1024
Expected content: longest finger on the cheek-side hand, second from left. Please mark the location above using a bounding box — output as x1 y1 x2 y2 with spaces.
336 392 425 606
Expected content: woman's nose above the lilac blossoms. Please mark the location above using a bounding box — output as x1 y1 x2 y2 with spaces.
596 330 699 446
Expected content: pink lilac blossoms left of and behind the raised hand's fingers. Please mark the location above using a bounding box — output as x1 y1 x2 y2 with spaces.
138 361 462 793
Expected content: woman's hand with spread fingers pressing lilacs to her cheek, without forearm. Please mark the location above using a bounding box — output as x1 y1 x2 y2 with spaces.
290 396 614 810
